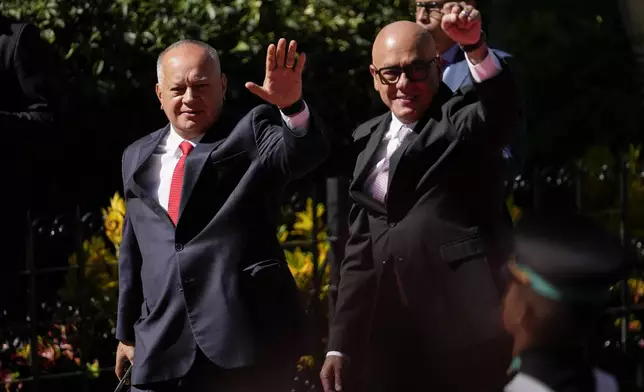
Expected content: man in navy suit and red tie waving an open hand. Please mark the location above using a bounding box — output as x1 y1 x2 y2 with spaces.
116 39 327 391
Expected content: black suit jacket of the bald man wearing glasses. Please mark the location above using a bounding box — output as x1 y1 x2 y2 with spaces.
328 60 518 361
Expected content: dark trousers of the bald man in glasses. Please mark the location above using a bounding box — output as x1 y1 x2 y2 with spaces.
360 268 510 392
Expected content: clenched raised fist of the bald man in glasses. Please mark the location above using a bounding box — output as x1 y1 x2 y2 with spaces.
441 2 481 45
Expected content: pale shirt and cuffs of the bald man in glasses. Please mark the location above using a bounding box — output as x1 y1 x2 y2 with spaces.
326 50 502 357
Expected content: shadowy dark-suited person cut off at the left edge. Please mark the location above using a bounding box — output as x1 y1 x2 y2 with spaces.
0 15 60 317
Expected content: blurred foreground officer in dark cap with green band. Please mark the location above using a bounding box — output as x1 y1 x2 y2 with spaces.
503 214 625 392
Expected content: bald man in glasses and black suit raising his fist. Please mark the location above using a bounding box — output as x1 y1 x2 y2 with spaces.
321 3 518 392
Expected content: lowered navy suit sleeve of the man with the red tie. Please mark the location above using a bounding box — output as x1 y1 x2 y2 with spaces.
116 151 143 342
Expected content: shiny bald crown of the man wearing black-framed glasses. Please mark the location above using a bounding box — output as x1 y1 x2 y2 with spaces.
371 20 436 67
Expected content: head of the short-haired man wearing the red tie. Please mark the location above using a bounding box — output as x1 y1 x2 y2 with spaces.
156 43 226 139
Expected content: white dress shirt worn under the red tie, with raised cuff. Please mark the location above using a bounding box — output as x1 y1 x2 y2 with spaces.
141 103 310 211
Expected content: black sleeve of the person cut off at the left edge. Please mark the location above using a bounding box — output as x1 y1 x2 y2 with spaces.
0 24 56 132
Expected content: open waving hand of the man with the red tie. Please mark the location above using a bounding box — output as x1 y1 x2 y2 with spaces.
246 38 306 108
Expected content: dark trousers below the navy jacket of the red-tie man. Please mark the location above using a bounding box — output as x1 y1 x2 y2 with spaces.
131 350 295 392
